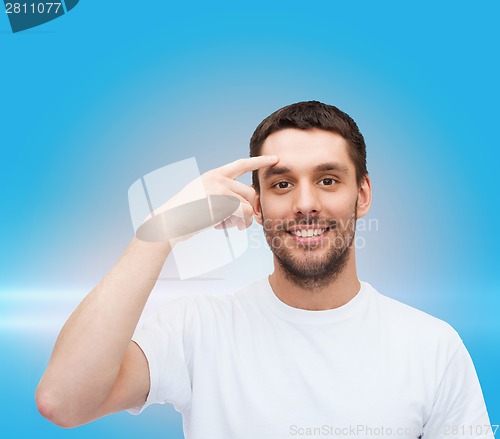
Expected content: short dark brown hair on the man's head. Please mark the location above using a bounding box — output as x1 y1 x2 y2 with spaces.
250 101 368 192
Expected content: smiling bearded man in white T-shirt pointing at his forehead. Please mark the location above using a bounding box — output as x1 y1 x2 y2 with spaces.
37 102 492 439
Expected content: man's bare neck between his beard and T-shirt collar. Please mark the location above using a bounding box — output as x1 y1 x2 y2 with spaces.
269 251 361 311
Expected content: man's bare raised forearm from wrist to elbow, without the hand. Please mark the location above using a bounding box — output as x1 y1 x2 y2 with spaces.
37 238 171 424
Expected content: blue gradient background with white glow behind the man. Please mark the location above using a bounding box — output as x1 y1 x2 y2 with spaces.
0 0 500 439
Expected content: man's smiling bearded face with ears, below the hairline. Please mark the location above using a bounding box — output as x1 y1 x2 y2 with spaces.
254 129 371 286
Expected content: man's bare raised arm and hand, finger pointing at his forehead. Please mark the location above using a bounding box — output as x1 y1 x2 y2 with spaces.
36 156 278 427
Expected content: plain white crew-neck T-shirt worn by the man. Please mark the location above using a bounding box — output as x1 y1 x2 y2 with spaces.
129 278 493 439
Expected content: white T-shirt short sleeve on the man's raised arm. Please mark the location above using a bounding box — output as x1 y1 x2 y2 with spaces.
127 297 194 415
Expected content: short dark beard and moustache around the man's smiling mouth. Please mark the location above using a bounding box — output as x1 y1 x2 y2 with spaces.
261 203 357 289
